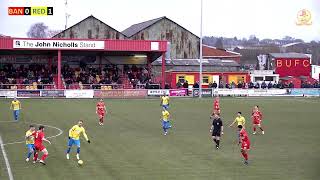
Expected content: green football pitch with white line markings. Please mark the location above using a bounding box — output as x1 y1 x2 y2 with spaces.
0 98 320 180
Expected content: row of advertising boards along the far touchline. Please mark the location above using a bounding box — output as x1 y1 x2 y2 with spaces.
0 89 320 99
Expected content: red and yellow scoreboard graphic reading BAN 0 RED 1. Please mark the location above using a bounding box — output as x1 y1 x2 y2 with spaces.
8 6 53 16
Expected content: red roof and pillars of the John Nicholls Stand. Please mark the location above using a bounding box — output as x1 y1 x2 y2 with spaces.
0 37 167 89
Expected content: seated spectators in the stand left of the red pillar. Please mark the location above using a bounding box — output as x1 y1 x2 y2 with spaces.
0 64 54 89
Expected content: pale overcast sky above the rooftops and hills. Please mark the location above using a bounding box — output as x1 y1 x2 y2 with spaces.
0 0 320 41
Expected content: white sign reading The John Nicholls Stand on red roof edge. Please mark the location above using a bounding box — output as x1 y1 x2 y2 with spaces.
13 39 104 49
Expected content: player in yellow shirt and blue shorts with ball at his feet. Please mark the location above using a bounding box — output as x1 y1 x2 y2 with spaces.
67 120 90 160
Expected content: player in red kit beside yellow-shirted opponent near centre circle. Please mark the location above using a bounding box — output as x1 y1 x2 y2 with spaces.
32 126 51 165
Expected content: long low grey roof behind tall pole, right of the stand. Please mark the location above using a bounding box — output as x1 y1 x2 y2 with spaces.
152 59 240 67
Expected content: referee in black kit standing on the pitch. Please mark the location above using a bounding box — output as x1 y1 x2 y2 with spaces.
210 113 223 149
